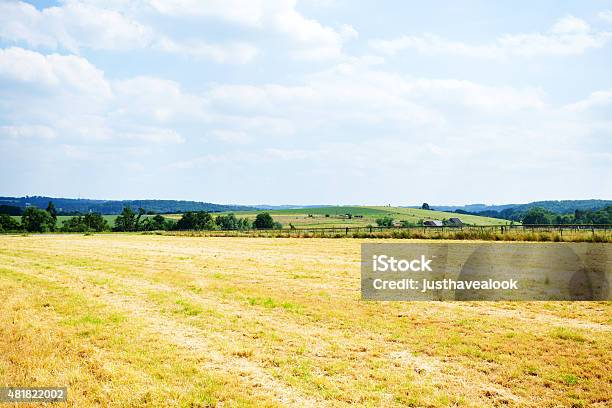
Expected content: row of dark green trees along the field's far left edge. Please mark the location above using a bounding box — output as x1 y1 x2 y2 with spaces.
0 201 282 232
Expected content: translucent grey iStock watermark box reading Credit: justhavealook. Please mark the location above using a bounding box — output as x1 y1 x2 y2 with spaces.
361 242 612 300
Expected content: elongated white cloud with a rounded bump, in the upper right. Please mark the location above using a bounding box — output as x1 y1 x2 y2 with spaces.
370 16 612 59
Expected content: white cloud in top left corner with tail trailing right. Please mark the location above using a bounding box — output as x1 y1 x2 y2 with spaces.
0 1 257 64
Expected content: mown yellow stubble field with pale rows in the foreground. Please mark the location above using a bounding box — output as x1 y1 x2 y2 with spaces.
0 235 612 407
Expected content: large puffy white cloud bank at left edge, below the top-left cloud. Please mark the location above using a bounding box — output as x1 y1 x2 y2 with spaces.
0 47 202 144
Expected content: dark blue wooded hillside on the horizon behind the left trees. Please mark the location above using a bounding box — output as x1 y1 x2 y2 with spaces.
0 196 255 214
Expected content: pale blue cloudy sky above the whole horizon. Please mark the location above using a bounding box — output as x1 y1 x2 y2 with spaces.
0 0 612 205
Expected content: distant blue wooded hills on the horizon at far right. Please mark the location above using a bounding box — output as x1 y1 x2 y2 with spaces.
424 200 612 214
